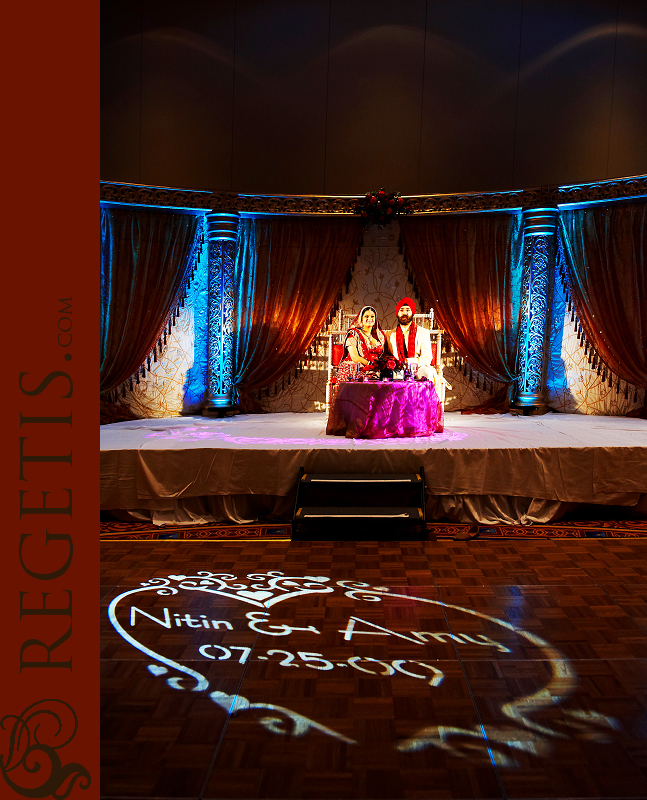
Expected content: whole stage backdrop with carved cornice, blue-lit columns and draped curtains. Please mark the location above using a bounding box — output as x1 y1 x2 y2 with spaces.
101 176 647 417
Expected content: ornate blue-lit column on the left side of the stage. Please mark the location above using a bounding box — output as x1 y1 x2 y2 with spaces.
202 212 238 417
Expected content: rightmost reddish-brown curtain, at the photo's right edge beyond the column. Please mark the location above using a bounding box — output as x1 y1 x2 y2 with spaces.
559 201 647 388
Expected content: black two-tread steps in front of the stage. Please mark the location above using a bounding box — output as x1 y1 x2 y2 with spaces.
292 467 426 541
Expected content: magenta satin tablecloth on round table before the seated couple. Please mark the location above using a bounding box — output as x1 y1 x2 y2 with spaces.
326 381 444 439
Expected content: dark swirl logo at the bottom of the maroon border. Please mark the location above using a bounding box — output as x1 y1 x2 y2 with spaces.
0 700 91 800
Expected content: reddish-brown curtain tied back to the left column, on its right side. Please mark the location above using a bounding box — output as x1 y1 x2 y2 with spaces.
234 217 362 411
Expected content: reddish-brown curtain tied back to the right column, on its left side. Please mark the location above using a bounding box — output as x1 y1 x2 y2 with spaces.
400 214 521 410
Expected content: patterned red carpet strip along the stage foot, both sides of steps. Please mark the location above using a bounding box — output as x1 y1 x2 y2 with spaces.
99 520 647 541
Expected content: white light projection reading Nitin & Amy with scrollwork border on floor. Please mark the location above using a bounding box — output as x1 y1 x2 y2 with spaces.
108 570 620 768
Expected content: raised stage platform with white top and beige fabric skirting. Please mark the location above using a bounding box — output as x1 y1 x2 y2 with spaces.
101 412 647 524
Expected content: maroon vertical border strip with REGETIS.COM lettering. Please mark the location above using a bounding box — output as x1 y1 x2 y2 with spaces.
0 0 99 798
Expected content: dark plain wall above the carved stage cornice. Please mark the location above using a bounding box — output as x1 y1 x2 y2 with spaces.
101 0 647 194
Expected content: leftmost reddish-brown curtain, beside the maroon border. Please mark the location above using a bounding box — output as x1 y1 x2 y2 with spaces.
101 206 197 395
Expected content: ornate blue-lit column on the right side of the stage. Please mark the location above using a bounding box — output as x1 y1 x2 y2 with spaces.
514 208 557 412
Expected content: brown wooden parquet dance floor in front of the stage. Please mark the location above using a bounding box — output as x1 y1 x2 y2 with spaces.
101 538 647 800
